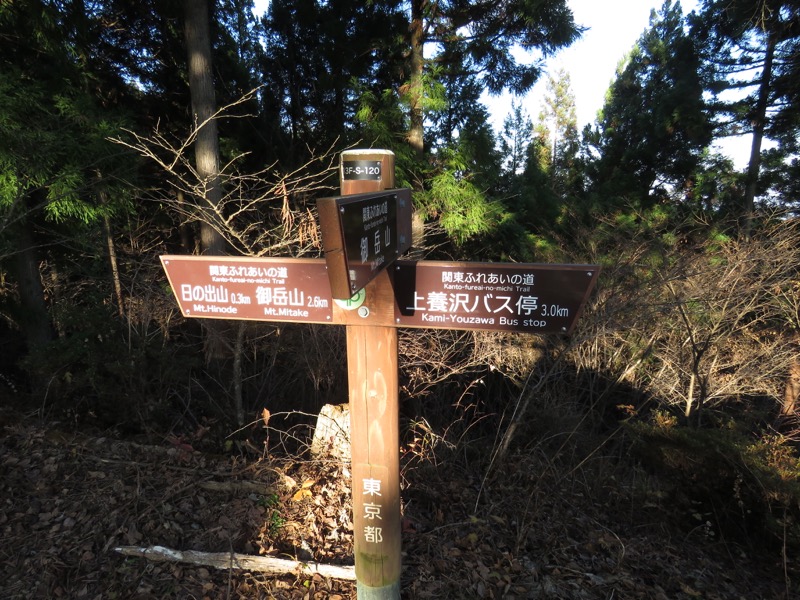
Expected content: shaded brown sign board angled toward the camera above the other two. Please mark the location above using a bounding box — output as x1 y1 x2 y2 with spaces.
317 189 411 299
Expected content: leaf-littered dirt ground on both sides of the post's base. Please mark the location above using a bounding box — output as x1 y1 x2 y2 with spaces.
0 418 800 600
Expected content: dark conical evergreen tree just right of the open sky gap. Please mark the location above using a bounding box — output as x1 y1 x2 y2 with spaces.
589 0 711 209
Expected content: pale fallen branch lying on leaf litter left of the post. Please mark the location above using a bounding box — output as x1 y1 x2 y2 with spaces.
114 546 356 580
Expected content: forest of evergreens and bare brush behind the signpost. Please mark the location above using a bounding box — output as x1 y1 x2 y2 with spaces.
0 0 800 592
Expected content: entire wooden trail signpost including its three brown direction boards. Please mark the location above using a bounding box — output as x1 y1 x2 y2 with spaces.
161 150 600 600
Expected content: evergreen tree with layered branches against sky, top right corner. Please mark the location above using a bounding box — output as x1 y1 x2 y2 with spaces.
691 0 800 221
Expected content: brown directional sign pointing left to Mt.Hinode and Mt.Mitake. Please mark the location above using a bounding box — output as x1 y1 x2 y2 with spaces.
161 256 333 323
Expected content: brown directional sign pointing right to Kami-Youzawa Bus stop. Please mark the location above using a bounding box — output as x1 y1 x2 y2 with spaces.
394 261 600 333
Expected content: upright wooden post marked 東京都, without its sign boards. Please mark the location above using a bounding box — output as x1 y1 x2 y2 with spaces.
340 150 401 600
